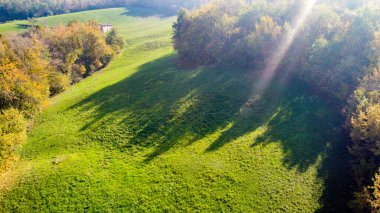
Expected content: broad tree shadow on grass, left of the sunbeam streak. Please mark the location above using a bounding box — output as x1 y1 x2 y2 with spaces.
72 56 255 156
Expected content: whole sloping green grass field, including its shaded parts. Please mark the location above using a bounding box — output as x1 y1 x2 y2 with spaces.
0 8 349 212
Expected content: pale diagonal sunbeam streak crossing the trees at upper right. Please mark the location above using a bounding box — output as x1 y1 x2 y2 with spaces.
254 0 317 96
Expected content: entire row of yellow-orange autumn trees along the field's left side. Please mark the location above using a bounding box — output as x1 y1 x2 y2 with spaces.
0 21 124 171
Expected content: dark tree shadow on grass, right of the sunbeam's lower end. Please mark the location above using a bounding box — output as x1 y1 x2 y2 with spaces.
207 79 353 212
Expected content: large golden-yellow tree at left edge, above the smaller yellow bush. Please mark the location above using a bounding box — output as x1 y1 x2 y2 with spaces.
0 36 49 117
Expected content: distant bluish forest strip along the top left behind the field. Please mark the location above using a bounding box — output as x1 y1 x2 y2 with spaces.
0 0 210 22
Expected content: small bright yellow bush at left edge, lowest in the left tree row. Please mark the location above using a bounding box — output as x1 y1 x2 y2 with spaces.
0 109 27 171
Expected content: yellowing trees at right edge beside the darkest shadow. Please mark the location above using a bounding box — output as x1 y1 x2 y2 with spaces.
348 37 380 212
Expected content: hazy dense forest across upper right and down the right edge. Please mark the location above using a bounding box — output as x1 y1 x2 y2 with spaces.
173 0 380 212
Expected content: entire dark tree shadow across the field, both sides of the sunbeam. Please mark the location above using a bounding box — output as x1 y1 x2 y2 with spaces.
72 55 350 212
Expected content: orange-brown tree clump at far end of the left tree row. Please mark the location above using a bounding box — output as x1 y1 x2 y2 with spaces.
40 21 114 80
